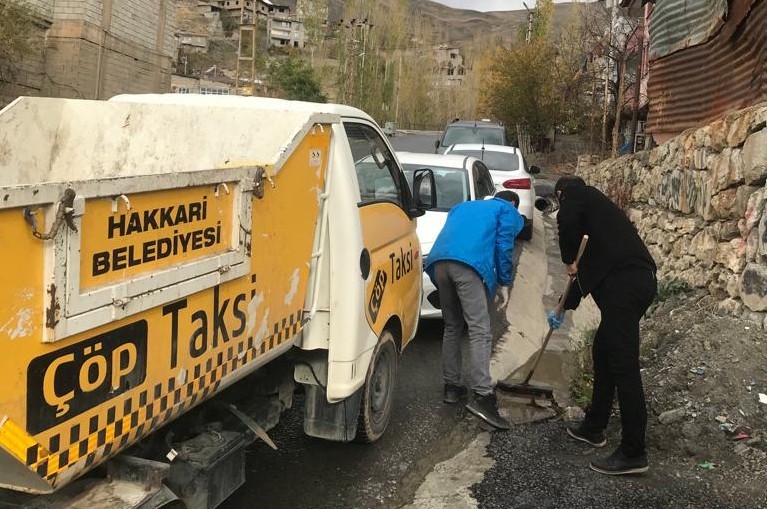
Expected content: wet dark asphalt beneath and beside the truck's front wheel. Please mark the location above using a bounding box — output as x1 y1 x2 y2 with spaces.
221 320 480 509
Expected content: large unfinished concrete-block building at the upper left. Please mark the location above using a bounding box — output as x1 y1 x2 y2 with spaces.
0 0 176 104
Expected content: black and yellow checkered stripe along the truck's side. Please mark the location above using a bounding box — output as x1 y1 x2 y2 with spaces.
15 310 306 485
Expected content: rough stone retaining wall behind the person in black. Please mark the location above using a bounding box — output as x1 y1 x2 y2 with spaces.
577 103 767 328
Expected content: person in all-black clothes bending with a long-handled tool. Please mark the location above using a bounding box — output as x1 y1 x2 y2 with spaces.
549 177 657 475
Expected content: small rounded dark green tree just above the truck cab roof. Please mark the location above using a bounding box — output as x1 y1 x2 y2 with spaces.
267 55 327 103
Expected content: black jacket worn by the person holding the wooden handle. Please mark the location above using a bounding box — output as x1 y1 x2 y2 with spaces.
557 183 656 309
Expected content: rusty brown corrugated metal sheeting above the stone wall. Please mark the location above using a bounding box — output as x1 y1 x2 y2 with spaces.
647 0 767 142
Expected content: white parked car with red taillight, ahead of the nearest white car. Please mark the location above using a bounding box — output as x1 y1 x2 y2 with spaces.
445 144 541 240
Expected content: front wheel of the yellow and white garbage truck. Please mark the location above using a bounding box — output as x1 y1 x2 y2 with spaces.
356 330 397 443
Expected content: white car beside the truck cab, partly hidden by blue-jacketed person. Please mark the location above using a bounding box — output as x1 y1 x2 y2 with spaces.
397 152 495 318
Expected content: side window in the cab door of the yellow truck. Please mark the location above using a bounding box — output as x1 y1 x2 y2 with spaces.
344 122 404 205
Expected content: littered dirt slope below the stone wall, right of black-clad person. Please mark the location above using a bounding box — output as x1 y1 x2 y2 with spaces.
632 292 767 501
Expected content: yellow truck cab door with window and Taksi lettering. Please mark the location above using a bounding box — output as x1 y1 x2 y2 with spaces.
344 121 422 347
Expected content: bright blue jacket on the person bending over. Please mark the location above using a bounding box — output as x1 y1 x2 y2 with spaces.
424 198 525 295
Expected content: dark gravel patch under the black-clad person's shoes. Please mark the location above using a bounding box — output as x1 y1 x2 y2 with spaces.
472 421 767 509
